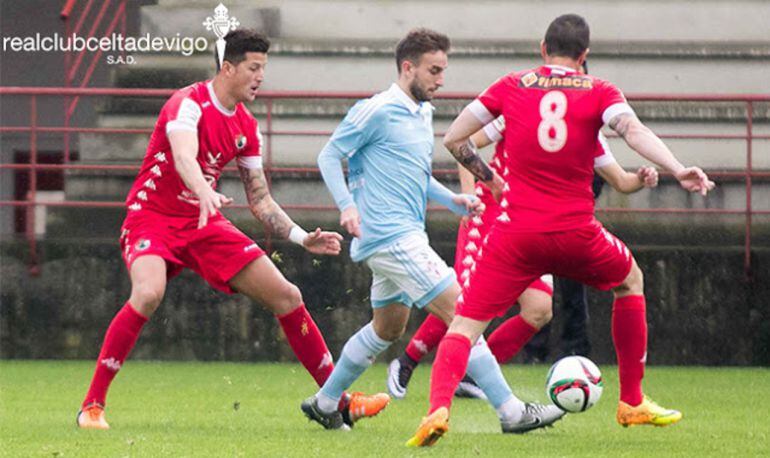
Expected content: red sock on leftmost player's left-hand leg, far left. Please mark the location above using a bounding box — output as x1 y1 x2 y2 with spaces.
83 302 147 407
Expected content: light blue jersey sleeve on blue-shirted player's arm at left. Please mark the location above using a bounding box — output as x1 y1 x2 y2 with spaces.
324 98 387 158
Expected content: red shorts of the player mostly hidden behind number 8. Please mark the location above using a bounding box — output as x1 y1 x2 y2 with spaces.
454 192 553 296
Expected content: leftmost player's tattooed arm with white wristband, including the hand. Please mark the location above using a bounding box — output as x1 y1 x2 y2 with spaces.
238 165 342 254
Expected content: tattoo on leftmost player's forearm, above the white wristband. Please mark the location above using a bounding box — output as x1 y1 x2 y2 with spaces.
238 167 295 238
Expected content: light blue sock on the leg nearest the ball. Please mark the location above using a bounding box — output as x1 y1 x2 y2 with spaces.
467 336 521 414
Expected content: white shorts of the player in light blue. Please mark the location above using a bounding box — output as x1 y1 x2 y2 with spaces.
366 232 456 308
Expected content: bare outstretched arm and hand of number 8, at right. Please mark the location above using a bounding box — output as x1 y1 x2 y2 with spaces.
608 112 714 196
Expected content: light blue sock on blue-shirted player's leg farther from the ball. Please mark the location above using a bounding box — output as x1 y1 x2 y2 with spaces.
317 322 392 412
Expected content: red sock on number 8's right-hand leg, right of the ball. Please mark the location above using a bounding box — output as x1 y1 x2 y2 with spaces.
612 296 647 406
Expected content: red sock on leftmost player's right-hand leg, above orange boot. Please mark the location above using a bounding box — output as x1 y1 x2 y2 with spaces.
276 304 334 386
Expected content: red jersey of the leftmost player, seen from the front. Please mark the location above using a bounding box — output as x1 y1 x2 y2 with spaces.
126 81 262 218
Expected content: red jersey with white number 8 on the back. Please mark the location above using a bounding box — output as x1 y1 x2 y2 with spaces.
469 66 633 232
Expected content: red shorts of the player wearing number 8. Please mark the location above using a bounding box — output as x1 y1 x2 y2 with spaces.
457 221 633 321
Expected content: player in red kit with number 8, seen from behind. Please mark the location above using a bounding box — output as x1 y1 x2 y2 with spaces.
407 14 714 446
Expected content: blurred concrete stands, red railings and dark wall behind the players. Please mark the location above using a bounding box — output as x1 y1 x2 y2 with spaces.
0 0 770 366
